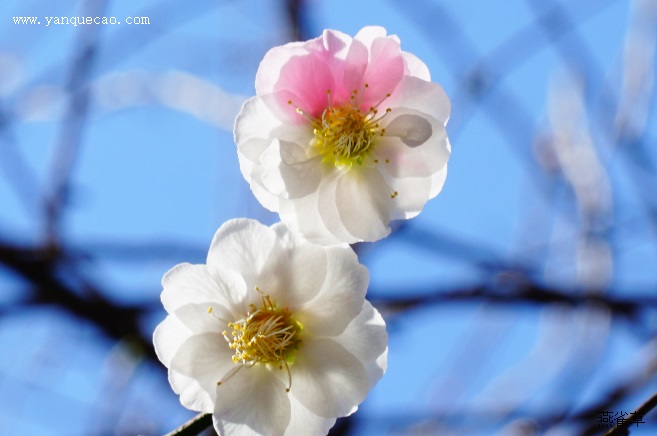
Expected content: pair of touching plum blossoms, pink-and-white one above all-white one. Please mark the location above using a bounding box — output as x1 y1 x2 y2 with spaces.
153 27 450 435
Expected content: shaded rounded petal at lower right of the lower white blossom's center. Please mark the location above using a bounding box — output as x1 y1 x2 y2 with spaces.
290 338 370 418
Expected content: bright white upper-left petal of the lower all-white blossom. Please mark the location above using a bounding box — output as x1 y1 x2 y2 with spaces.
160 263 246 313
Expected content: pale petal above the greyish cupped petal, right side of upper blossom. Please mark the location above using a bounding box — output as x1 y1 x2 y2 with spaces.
386 76 451 125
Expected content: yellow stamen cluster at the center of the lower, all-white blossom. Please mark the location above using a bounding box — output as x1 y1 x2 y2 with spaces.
218 288 302 392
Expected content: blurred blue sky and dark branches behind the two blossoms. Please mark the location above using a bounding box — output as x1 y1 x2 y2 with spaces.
0 0 657 435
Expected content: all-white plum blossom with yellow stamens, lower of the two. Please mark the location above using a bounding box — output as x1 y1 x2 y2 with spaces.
153 219 388 435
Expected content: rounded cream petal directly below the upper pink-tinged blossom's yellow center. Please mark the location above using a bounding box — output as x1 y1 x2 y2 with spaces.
335 168 391 241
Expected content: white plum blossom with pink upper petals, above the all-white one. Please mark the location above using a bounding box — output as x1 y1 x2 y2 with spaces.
235 27 451 244
